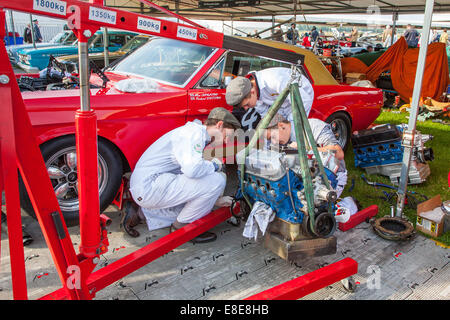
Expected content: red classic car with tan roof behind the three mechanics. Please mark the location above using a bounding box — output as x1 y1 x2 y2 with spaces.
18 38 383 225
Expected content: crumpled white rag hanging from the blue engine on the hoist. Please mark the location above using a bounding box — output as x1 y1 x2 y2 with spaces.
242 201 275 241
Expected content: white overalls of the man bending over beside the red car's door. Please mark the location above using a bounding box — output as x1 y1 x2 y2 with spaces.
251 67 314 121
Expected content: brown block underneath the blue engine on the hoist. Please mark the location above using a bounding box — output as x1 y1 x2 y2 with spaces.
264 218 337 262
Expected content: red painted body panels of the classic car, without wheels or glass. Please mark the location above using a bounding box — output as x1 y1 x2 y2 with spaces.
23 49 383 170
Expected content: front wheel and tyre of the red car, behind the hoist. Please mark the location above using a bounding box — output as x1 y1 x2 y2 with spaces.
20 136 123 227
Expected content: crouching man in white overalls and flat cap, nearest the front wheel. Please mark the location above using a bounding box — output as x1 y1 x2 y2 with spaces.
122 108 240 243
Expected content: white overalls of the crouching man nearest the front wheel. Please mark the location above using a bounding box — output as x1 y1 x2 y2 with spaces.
130 122 226 230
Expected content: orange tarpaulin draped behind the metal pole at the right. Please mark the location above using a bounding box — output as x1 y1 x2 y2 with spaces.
341 37 449 101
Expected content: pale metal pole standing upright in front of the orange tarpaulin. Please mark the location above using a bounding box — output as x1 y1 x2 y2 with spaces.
396 0 434 218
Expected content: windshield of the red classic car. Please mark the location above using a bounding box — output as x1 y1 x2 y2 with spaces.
108 39 215 85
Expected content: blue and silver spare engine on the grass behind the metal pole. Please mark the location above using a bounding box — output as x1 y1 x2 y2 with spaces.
352 124 434 184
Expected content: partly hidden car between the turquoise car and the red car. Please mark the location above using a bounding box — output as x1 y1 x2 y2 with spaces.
56 34 152 73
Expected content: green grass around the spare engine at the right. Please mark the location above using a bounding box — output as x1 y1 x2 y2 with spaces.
342 110 450 246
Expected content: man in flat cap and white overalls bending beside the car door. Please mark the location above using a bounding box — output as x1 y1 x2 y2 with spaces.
225 67 314 130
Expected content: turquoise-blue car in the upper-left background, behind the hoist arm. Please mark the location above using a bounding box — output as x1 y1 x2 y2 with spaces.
18 30 137 72
